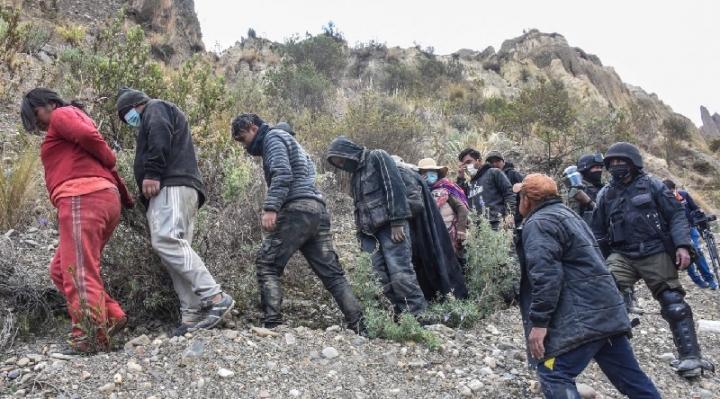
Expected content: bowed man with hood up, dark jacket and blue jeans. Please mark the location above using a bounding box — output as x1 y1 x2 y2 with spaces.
327 136 427 316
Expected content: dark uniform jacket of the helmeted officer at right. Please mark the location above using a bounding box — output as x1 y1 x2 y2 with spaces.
592 171 693 260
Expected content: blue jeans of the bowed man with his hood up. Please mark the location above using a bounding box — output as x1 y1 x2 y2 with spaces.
361 221 427 316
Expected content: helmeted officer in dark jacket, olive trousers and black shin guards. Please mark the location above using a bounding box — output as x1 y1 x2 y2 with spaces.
592 142 715 378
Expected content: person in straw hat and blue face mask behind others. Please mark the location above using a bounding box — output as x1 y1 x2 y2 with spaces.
417 158 469 258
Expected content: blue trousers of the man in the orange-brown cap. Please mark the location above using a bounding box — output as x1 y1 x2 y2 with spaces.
537 335 661 399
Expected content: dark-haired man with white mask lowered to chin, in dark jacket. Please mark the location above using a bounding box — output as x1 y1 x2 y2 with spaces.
456 148 517 230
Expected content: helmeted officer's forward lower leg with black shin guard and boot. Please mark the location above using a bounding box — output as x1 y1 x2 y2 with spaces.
659 291 715 378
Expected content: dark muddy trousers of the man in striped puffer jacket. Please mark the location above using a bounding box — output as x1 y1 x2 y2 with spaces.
255 199 362 328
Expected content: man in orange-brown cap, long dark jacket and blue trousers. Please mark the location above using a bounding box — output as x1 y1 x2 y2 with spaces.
513 173 660 399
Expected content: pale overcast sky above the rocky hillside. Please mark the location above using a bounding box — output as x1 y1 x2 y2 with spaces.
195 0 720 126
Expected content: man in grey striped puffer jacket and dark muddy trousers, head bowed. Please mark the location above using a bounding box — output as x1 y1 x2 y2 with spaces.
232 114 364 334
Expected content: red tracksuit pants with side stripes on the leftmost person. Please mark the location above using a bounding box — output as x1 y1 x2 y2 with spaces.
50 189 125 342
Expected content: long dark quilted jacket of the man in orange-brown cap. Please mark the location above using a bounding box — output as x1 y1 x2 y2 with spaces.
516 198 630 364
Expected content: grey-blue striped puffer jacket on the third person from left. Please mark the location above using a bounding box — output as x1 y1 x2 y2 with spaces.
247 123 325 212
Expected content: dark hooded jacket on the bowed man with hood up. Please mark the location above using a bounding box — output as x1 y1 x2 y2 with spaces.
327 136 411 234
